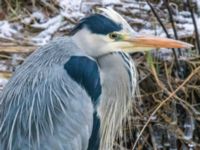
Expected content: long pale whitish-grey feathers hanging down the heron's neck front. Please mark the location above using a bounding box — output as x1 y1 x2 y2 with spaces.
98 52 136 150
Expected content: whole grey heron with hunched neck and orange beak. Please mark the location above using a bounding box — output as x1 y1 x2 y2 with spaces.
0 9 191 150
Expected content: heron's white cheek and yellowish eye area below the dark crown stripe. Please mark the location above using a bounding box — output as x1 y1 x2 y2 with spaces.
72 28 138 57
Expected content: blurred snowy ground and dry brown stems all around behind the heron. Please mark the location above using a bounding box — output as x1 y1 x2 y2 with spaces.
0 0 200 150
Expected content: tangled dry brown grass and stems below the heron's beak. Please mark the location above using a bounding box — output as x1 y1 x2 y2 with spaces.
119 54 200 149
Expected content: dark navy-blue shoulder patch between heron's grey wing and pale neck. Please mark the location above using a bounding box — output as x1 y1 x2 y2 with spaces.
64 56 101 102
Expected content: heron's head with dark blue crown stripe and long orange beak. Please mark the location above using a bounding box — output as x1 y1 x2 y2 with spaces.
71 8 192 57
